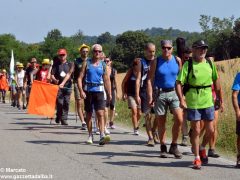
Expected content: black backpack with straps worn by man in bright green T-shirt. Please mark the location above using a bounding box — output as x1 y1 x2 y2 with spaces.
183 59 213 95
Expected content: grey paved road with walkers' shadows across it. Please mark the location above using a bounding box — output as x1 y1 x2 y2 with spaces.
0 104 240 180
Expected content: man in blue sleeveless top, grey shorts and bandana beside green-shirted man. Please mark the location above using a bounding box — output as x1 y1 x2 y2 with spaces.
148 40 183 158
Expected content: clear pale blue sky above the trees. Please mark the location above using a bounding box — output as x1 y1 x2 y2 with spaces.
0 0 240 43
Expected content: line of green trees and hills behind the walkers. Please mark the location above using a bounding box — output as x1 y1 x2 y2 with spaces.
0 15 240 72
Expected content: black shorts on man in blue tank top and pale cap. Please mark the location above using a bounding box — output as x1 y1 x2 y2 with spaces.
84 92 106 113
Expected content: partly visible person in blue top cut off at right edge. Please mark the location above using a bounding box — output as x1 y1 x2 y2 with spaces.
232 73 240 168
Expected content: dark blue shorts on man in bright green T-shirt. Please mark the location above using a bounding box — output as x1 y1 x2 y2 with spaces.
187 106 215 121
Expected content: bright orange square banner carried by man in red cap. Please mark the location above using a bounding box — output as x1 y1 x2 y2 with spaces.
27 81 59 117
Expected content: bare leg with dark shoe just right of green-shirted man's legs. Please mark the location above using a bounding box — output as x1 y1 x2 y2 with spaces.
208 110 219 158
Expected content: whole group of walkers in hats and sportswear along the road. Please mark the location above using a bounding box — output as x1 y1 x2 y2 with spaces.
0 40 240 169
